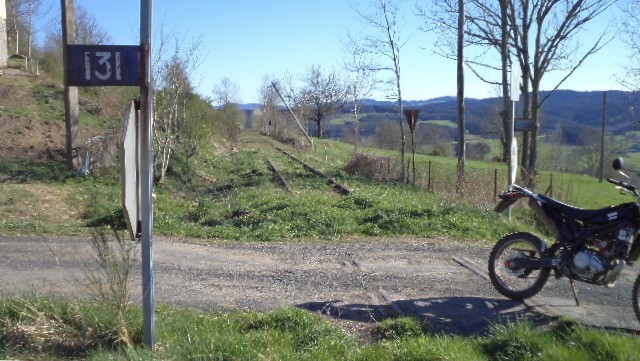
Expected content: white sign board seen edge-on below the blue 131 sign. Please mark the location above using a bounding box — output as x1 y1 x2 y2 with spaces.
120 100 140 241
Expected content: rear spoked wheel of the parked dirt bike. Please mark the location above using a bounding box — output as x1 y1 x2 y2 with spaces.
489 232 551 300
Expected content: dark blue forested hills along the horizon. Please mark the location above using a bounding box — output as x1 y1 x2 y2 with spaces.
243 90 640 138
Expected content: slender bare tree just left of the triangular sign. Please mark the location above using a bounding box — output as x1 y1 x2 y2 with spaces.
357 0 408 182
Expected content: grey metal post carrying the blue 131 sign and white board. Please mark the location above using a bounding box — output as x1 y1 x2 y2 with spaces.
62 0 155 347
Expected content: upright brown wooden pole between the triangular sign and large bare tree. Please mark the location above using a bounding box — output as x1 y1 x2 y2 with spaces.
456 0 465 194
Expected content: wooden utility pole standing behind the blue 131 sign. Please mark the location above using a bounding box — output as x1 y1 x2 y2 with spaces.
61 0 80 169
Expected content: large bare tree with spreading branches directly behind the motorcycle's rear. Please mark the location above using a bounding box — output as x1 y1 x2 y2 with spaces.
508 0 616 184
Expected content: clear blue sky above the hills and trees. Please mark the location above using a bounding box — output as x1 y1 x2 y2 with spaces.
43 0 628 103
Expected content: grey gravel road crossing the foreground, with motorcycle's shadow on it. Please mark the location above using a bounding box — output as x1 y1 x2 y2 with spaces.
0 236 640 335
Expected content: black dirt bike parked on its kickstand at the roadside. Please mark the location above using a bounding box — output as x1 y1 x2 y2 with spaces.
489 158 640 320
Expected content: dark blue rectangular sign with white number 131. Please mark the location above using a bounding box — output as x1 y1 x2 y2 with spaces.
67 45 142 86
